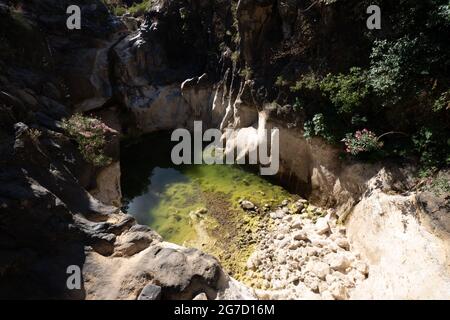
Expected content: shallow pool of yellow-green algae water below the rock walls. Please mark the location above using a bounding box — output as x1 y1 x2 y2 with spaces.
121 133 295 276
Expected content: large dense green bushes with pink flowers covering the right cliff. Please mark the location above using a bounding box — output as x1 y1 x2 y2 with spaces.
284 0 450 168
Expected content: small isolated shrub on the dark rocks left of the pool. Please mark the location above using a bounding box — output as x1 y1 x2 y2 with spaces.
63 113 112 167
